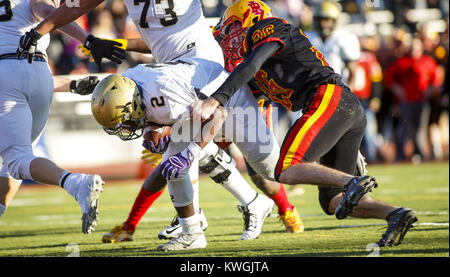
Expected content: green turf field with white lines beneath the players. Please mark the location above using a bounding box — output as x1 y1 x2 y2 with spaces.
0 163 449 257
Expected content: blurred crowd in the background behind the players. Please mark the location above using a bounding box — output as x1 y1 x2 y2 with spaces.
48 0 449 163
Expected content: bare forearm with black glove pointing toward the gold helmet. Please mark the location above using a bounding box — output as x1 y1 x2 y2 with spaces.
53 76 99 95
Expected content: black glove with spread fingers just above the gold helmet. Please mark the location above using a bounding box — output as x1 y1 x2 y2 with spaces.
84 35 125 71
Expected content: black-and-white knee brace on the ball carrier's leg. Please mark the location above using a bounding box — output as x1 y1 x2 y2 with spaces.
199 145 235 184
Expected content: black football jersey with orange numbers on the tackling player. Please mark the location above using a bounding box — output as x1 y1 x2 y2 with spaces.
244 18 341 111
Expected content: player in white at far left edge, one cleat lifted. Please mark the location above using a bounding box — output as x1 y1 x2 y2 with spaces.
0 0 103 234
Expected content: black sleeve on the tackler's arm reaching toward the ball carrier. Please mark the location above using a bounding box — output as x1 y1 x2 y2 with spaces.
211 42 281 106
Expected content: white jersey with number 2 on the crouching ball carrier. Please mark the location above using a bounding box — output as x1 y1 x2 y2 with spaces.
122 59 227 125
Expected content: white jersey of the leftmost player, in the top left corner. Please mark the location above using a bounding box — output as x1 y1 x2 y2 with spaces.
0 0 50 55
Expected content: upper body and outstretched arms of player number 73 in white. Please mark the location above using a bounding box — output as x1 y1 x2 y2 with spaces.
19 0 223 68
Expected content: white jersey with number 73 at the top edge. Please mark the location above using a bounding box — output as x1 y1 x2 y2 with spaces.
123 0 223 64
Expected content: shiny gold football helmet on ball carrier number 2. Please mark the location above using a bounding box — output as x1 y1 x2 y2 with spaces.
91 74 146 140
